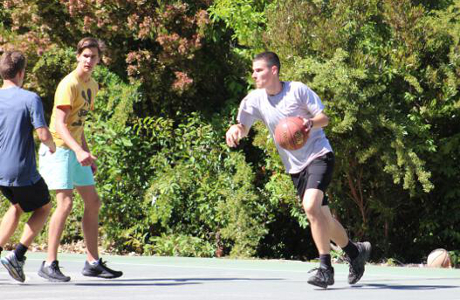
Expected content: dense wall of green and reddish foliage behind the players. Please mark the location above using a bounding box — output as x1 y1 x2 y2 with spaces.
0 0 460 262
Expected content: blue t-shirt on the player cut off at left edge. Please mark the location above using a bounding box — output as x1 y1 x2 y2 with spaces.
0 87 46 186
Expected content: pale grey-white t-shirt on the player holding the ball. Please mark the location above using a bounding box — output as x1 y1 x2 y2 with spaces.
237 81 332 174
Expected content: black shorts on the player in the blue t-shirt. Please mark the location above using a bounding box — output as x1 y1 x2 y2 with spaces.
0 178 50 212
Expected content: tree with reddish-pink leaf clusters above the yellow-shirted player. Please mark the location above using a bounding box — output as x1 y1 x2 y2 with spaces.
0 0 246 116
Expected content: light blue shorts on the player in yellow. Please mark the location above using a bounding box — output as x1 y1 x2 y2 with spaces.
38 144 94 190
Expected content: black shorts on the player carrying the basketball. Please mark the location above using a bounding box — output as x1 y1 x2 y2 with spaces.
291 152 335 205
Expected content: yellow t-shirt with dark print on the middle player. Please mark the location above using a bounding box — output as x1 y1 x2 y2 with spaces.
50 71 99 148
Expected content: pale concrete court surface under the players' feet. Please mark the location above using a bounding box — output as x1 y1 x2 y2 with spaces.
0 251 460 300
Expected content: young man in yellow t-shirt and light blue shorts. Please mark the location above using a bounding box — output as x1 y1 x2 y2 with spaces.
38 38 123 282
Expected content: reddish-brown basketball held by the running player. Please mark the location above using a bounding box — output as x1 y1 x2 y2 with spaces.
275 117 310 150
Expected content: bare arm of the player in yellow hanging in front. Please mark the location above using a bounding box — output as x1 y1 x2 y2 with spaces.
55 106 96 166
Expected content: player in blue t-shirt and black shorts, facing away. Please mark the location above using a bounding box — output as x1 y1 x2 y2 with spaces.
0 51 56 282
